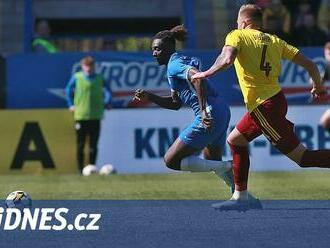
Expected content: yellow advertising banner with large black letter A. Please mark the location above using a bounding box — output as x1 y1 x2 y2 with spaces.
0 109 78 174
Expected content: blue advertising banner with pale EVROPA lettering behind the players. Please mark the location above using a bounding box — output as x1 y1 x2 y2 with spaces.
6 48 325 108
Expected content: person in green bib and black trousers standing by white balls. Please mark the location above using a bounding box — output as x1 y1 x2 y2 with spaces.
65 56 111 171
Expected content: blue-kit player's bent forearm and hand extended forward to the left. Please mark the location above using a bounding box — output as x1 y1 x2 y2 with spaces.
133 89 182 110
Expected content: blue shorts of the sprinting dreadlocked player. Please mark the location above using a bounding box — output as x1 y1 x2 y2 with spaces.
179 98 230 150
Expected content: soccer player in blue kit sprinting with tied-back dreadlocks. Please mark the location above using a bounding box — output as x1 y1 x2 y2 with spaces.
134 25 234 191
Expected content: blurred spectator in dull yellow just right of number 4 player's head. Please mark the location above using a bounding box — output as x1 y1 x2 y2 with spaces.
262 0 291 33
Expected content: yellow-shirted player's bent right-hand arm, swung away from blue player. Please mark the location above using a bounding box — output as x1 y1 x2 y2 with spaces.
292 52 327 99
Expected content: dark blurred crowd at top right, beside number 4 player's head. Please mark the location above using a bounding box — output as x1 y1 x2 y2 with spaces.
247 0 330 46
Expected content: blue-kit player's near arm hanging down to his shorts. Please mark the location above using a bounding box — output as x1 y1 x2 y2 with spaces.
188 68 213 129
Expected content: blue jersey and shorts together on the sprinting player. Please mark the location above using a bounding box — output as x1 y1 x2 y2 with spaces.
167 53 230 149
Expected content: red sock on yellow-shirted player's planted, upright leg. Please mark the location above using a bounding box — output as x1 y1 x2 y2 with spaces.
228 142 250 191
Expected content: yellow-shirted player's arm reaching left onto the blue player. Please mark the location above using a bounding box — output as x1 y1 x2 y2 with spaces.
192 46 237 80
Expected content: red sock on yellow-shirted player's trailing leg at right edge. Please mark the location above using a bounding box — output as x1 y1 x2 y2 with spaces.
299 150 330 168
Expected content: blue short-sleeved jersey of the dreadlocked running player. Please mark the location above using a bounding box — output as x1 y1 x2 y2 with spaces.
167 53 217 116
